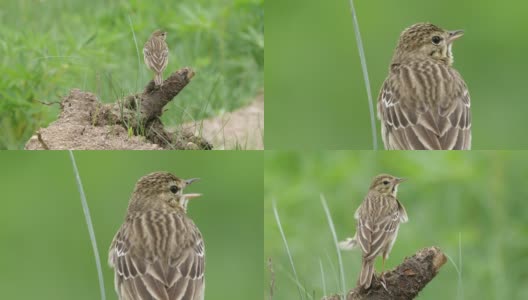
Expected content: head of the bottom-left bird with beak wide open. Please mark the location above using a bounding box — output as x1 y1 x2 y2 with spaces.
129 172 201 212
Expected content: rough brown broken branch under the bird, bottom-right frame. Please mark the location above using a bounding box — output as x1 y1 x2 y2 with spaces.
323 247 447 300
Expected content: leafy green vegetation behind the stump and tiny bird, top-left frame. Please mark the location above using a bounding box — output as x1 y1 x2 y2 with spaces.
0 0 264 149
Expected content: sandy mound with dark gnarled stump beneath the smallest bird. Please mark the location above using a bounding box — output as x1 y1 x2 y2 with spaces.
25 67 212 150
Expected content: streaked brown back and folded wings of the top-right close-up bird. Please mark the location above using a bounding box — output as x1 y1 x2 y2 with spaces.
378 64 471 150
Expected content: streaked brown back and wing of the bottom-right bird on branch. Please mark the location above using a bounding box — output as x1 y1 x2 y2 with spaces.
357 193 400 260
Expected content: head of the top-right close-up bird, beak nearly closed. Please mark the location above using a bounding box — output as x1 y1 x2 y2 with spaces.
393 23 464 65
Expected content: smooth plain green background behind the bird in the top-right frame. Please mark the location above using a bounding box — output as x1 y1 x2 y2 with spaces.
265 0 528 150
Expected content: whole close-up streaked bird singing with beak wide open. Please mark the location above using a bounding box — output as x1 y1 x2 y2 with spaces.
108 172 205 300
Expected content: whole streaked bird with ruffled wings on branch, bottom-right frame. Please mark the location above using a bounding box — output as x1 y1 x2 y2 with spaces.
339 174 408 289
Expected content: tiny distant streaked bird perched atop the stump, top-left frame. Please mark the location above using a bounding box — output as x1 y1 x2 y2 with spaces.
143 30 169 85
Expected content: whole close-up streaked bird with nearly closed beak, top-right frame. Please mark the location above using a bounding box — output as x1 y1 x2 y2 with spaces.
378 23 471 150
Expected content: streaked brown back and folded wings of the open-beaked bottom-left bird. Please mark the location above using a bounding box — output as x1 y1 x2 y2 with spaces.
109 212 205 300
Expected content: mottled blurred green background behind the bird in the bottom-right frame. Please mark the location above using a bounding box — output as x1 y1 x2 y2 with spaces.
263 151 528 300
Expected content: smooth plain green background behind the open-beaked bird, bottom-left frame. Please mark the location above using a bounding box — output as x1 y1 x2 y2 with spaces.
0 151 263 300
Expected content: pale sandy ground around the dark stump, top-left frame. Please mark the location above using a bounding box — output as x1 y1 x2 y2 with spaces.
25 85 264 150
